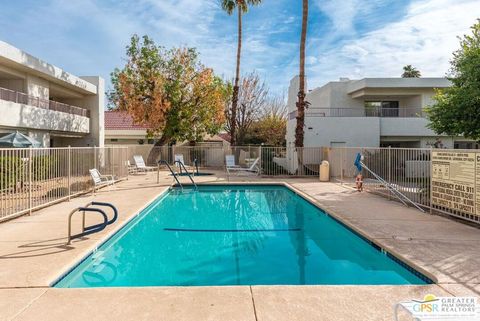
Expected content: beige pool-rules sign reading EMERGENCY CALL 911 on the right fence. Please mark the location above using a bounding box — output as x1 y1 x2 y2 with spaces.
431 151 480 216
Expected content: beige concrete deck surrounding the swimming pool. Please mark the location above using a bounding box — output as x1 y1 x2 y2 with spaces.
0 172 480 321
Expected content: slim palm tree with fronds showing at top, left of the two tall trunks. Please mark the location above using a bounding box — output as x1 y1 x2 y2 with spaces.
221 0 262 146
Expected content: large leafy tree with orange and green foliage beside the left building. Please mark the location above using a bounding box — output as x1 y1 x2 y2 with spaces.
108 35 229 145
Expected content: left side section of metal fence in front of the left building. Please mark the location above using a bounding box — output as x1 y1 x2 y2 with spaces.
0 147 128 221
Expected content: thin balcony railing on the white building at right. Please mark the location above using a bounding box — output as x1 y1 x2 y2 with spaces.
289 107 425 119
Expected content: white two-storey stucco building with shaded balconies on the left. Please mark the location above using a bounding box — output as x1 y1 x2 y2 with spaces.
0 41 105 147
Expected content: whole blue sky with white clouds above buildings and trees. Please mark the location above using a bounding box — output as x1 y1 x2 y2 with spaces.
0 0 480 94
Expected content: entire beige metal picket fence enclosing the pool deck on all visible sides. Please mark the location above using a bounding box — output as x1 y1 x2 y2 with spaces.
0 145 480 223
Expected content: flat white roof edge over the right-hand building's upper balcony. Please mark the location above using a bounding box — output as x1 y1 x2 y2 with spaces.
348 77 451 94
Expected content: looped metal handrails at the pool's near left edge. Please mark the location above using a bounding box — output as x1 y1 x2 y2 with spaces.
67 202 118 245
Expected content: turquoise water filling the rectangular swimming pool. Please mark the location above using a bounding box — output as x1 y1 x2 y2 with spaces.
55 185 428 288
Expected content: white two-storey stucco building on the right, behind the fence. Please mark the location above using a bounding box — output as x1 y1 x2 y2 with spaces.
286 77 476 148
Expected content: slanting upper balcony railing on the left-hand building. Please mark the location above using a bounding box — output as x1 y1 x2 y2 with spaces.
0 87 90 117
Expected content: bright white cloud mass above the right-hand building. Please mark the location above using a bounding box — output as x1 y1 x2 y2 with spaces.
308 0 480 86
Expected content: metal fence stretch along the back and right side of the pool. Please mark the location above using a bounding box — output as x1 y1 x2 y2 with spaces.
129 146 480 223
